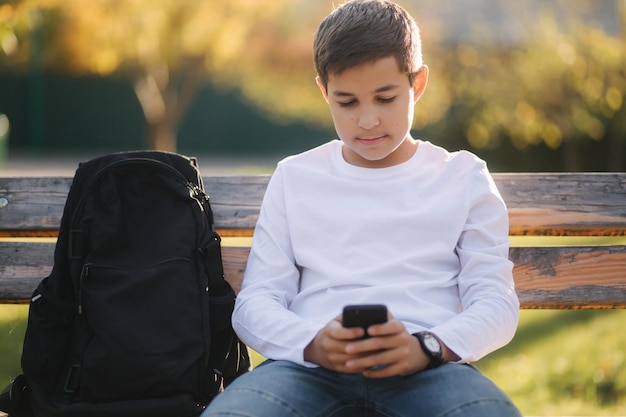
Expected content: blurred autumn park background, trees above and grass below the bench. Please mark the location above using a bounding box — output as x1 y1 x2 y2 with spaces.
0 0 626 415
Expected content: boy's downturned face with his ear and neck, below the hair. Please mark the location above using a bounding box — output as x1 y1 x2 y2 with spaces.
318 57 428 168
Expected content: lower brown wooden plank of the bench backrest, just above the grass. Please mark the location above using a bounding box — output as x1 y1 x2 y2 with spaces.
0 242 626 308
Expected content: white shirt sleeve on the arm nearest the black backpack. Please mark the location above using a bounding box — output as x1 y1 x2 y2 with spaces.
232 165 321 367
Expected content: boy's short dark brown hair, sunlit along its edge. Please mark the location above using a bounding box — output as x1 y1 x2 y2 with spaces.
313 0 422 87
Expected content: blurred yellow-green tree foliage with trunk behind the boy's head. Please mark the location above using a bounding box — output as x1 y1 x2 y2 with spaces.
0 0 626 171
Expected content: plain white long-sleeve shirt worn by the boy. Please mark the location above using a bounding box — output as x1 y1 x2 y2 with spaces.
233 141 519 366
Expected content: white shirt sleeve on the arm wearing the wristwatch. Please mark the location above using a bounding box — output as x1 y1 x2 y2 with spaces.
431 163 519 362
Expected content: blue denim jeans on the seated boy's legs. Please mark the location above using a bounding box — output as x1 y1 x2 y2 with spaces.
202 361 521 417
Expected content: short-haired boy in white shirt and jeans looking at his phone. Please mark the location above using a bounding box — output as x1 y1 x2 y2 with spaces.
204 0 520 417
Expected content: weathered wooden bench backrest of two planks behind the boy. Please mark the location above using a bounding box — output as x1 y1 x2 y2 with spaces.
0 173 626 308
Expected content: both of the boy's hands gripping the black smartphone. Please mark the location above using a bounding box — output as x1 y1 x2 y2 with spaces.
304 314 428 378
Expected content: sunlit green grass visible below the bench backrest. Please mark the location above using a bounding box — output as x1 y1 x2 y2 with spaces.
0 305 626 416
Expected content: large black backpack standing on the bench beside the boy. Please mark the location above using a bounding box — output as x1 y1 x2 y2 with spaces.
4 151 250 417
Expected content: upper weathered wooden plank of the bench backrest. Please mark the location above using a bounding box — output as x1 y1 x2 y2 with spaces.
0 173 626 236
